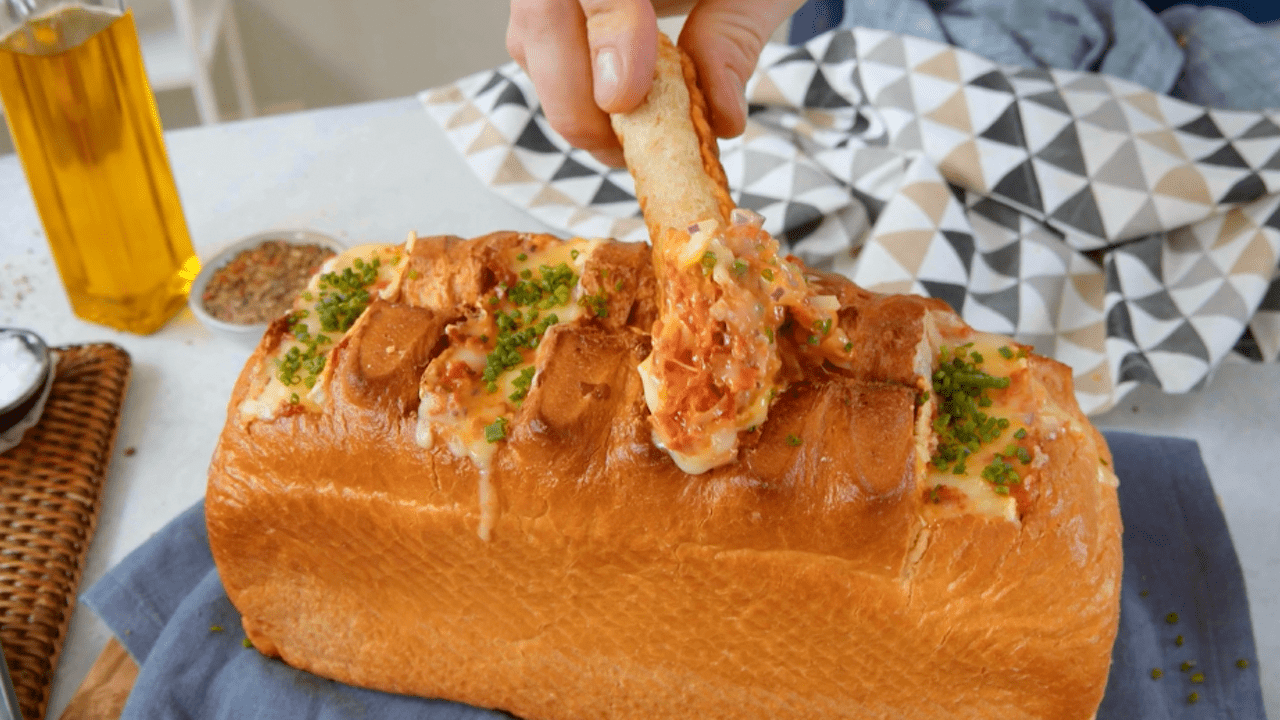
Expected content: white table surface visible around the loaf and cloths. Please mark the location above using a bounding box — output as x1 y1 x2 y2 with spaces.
0 97 1280 719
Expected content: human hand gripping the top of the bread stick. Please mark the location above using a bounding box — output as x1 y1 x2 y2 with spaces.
507 0 804 165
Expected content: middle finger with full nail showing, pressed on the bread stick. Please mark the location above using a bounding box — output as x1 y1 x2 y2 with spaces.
580 0 658 113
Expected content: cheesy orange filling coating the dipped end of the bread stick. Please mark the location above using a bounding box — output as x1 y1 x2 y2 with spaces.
639 208 850 474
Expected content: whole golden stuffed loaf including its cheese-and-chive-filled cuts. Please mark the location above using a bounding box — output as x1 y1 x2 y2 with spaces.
206 32 1120 720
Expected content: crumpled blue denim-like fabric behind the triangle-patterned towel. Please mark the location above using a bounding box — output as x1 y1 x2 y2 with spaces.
819 0 1280 110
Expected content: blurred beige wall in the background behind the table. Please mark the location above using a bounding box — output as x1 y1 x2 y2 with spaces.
0 0 701 154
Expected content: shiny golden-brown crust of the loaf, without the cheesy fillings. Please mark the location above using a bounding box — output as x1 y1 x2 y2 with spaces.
206 228 1120 720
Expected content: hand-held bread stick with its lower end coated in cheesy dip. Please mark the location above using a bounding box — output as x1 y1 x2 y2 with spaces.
612 37 851 473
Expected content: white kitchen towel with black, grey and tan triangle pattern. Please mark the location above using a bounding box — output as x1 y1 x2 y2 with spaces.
421 29 1280 413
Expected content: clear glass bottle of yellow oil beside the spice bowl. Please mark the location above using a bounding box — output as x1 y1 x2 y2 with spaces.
0 5 200 334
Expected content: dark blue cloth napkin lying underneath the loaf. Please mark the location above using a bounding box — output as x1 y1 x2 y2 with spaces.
82 433 1265 720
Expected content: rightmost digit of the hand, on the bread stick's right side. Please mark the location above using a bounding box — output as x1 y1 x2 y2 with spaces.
680 0 804 137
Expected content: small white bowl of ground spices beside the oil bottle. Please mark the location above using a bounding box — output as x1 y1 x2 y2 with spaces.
188 231 347 347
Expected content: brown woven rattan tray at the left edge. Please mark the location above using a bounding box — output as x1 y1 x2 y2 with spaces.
0 343 132 720
